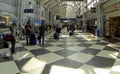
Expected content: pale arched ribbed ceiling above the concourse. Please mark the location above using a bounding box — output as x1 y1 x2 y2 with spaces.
41 0 84 16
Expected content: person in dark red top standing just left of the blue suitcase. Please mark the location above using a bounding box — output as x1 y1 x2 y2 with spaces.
25 21 32 45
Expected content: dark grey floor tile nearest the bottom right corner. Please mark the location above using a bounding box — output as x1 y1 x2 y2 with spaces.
87 56 115 68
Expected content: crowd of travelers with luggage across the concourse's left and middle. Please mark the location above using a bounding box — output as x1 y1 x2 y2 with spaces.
0 20 75 58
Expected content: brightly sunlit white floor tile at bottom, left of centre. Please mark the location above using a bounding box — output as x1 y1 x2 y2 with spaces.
22 57 46 74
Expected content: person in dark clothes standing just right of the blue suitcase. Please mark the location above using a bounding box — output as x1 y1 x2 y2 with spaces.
39 22 45 45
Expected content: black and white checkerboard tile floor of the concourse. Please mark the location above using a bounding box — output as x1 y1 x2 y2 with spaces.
0 30 120 74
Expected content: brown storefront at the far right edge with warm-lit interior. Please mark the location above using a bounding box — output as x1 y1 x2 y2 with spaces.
105 2 120 38
